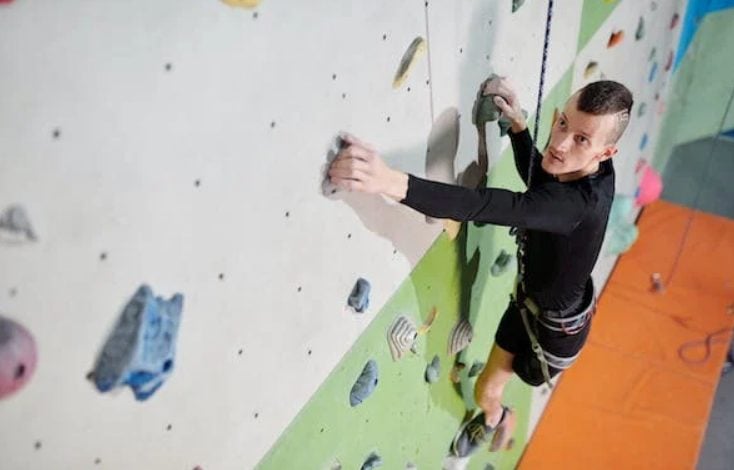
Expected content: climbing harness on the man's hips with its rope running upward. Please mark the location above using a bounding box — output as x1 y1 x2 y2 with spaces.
510 0 596 388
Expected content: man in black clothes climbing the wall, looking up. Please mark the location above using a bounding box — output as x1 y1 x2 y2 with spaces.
329 77 633 457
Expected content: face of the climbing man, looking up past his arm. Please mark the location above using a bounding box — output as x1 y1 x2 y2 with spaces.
542 95 617 181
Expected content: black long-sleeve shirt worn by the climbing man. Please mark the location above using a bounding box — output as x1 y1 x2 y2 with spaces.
400 129 614 310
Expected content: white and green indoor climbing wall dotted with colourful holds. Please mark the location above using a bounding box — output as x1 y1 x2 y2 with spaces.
0 0 685 469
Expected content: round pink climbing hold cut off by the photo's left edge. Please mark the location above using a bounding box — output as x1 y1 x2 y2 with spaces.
0 316 38 399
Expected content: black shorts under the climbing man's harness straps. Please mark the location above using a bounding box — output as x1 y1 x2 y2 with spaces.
494 300 591 387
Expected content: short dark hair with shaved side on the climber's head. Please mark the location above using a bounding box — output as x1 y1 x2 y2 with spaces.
576 80 634 143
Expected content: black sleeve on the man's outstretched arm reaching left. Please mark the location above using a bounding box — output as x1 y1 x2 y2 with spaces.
400 174 588 234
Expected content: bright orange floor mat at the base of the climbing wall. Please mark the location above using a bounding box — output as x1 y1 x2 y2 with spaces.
519 201 734 470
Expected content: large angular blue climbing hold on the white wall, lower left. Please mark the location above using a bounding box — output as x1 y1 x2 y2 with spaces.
91 284 183 400
